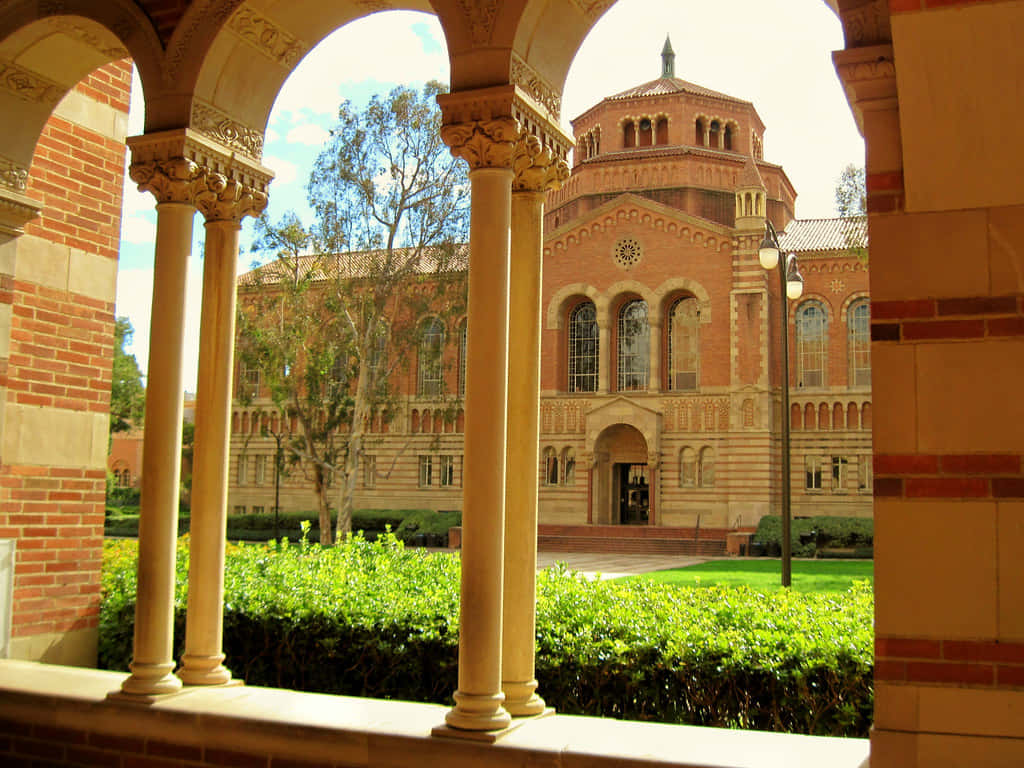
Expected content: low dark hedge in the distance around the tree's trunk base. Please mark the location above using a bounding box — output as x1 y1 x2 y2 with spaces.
103 508 462 547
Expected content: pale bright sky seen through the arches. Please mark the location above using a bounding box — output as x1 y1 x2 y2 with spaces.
117 0 864 391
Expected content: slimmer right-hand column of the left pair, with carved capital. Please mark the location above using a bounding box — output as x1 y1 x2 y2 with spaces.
178 173 268 685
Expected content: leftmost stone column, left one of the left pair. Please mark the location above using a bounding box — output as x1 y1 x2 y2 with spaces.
121 153 202 695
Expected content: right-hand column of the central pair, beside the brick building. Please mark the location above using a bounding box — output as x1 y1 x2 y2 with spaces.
502 133 568 716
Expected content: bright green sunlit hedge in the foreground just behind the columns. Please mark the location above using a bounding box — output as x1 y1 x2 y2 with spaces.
99 535 873 736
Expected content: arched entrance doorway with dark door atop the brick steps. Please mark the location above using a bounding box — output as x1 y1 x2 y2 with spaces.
592 424 654 525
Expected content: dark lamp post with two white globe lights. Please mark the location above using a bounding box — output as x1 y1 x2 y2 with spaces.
758 218 804 587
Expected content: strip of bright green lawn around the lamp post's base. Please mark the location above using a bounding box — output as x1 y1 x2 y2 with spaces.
630 557 874 592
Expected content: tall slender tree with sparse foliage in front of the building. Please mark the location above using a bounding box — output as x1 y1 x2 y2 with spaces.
238 82 469 544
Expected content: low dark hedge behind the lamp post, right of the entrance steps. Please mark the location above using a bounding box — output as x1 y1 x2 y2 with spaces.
754 515 874 557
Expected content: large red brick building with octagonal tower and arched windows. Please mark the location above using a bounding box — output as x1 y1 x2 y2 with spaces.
229 41 871 551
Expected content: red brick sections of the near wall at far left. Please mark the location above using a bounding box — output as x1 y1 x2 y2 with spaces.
0 61 131 663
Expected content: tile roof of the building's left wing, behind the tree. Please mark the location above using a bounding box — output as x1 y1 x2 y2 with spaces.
238 245 469 286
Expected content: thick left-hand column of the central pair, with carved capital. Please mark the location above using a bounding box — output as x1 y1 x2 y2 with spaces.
438 108 518 730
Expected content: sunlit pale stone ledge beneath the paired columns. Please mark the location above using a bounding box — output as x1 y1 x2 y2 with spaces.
0 660 868 768
